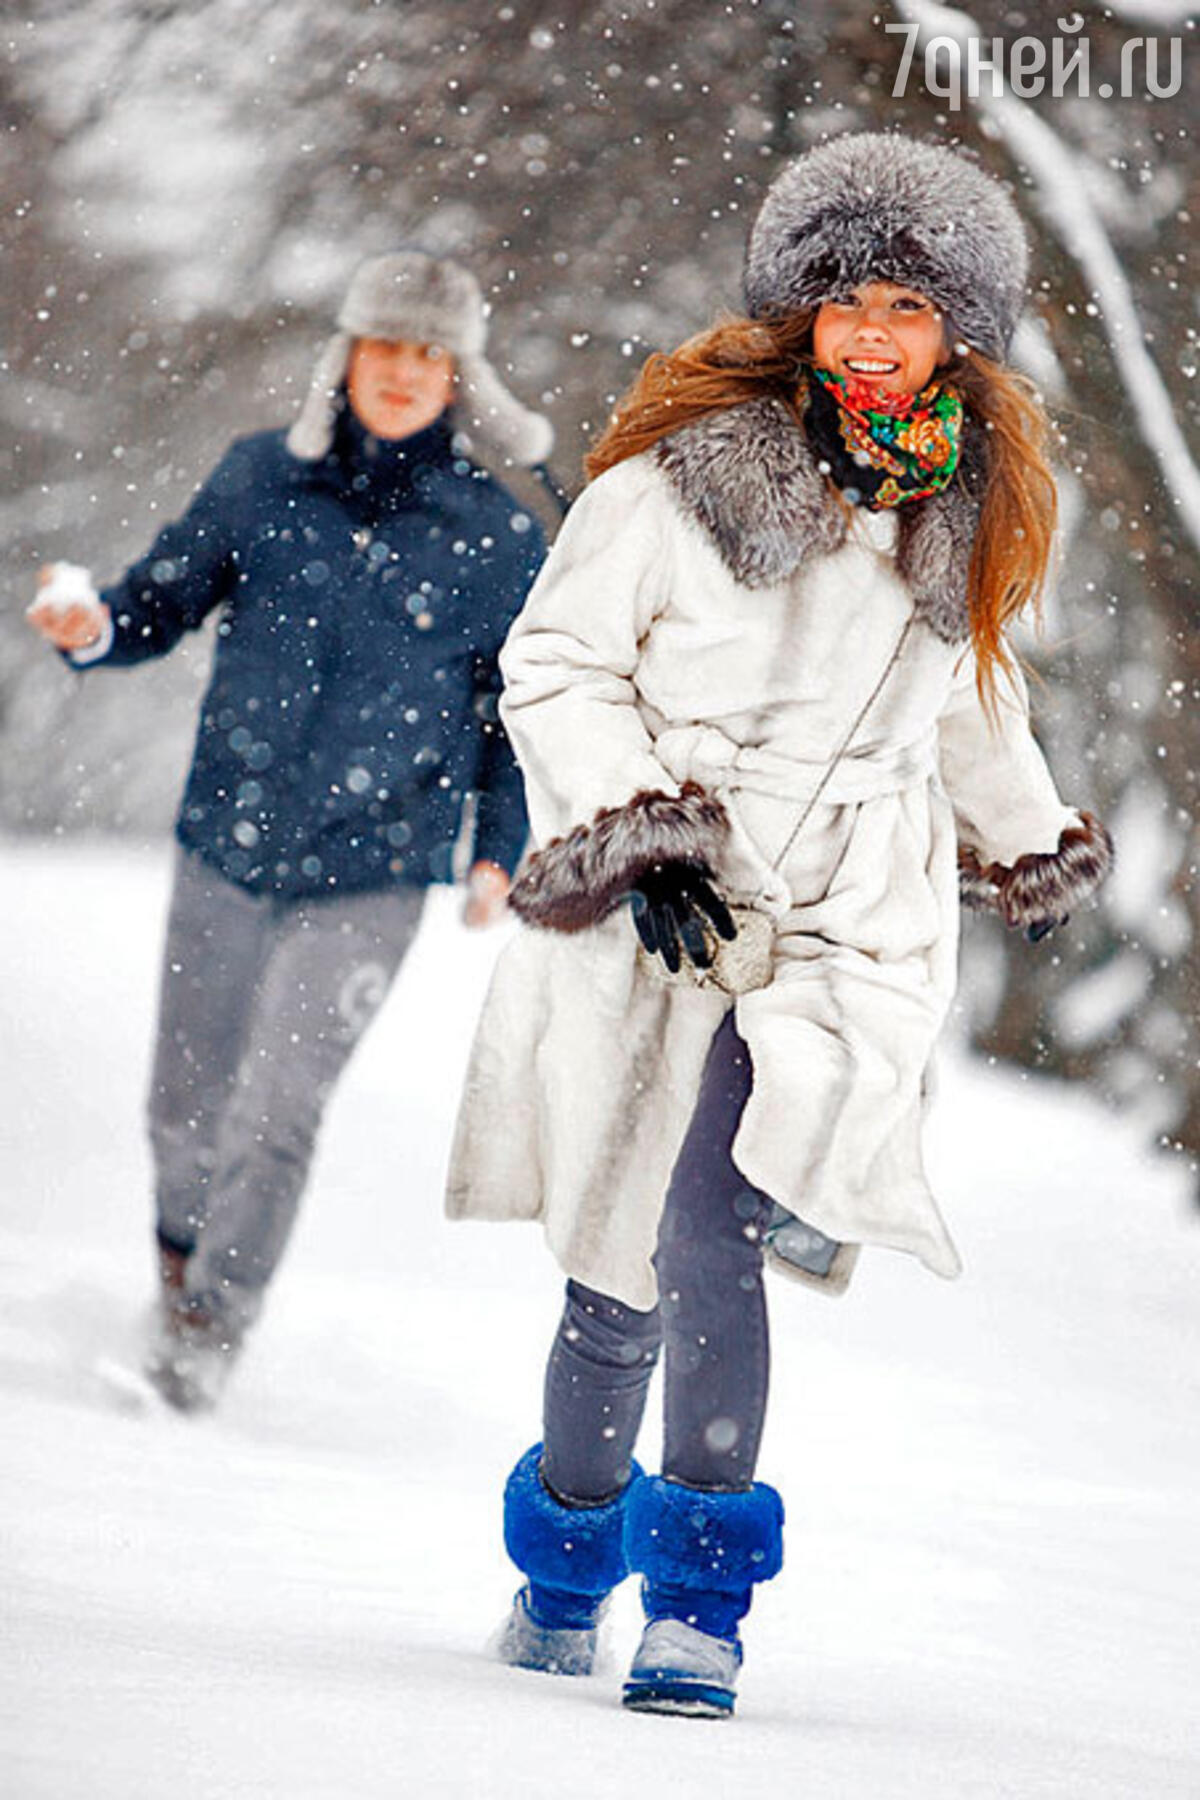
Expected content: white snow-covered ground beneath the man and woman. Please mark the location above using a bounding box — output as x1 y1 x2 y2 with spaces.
0 844 1200 1800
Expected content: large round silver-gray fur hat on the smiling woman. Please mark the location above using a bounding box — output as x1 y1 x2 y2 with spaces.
745 131 1029 360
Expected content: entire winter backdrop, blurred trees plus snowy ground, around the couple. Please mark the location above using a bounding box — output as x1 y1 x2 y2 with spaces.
0 14 1200 1800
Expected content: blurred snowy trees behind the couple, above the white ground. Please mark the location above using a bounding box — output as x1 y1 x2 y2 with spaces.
0 0 1200 1188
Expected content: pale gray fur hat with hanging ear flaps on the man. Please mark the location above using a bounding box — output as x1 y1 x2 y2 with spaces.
288 250 554 466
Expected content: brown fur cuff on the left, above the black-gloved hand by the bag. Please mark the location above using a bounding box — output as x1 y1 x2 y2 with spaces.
509 781 729 931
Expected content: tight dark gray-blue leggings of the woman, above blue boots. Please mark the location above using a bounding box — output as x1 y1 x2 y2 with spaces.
542 1012 772 1503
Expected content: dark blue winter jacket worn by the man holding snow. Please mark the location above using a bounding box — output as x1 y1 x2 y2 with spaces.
94 409 545 896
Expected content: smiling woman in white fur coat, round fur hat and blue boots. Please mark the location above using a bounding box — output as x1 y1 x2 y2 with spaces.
448 135 1112 1715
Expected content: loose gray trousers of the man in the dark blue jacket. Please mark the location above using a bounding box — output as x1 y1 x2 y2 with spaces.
149 851 425 1323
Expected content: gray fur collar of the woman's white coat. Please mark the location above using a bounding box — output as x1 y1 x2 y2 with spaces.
655 398 984 644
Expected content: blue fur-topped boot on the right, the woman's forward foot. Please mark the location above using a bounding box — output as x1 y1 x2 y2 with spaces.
622 1476 783 1719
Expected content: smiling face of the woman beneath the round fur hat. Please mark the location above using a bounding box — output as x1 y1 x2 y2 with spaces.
813 281 950 394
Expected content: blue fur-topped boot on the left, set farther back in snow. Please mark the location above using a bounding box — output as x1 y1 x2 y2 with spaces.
495 1444 640 1676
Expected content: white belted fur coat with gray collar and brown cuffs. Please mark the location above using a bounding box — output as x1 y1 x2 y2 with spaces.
448 401 1110 1309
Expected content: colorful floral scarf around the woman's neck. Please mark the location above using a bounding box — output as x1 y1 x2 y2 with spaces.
799 369 963 511
